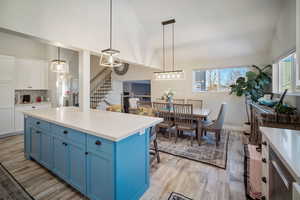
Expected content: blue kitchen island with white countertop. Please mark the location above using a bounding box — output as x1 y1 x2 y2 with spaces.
24 107 162 200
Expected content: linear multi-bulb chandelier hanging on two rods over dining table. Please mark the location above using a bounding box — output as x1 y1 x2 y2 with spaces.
154 19 184 80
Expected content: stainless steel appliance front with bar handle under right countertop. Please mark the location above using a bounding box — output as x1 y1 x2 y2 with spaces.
269 148 295 200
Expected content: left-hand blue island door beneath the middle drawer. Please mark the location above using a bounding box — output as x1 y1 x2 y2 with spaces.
53 137 68 180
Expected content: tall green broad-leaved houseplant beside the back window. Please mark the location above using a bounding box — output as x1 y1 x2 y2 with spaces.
230 65 272 124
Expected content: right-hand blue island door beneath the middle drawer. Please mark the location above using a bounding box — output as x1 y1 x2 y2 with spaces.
68 144 86 193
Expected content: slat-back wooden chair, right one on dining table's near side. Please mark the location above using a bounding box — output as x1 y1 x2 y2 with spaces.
173 104 197 146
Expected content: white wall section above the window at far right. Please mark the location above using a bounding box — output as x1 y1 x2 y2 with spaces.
271 0 298 60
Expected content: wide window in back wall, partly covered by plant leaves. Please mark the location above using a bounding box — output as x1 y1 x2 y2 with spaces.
193 67 248 92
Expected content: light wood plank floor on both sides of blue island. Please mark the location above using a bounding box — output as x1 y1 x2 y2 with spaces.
0 133 245 200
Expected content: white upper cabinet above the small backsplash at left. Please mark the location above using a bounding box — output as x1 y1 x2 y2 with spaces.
15 59 48 90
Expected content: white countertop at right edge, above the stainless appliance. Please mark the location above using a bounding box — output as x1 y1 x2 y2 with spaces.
260 127 300 183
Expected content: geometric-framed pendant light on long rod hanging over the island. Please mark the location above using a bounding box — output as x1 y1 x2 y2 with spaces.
100 0 122 67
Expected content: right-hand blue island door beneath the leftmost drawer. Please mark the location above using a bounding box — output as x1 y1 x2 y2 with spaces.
41 131 53 169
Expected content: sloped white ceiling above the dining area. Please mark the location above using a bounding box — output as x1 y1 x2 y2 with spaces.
129 0 284 64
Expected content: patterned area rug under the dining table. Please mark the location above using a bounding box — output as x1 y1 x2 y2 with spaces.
157 130 230 169
